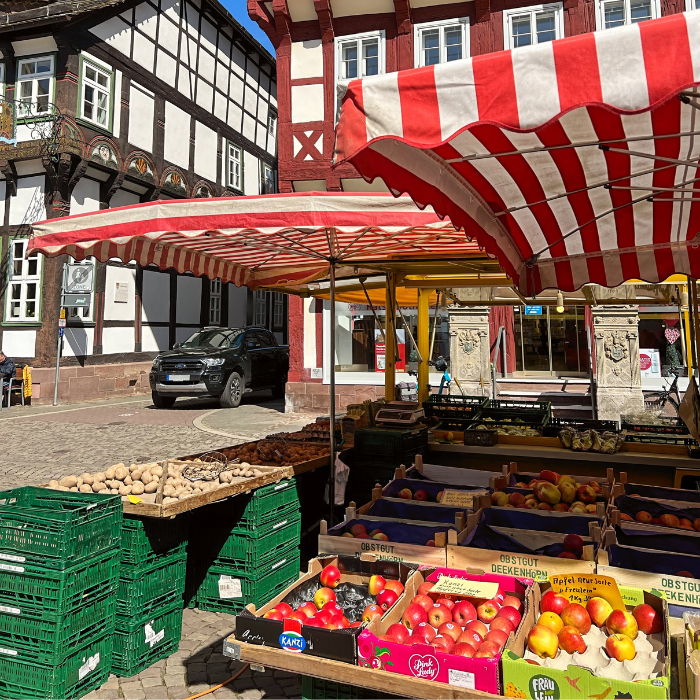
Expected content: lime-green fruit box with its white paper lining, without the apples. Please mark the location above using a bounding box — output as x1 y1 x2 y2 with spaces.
501 582 671 700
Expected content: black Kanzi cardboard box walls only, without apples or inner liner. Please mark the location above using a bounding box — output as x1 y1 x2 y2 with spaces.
236 556 413 664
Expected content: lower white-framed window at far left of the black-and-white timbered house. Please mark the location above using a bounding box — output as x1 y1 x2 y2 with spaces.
5 238 42 323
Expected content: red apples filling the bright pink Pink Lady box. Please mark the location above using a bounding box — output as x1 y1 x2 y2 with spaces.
379 581 522 659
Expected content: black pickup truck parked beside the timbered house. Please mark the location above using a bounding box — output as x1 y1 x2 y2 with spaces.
149 328 289 408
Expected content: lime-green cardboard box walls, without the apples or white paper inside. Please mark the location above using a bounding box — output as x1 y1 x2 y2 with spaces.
501 583 671 700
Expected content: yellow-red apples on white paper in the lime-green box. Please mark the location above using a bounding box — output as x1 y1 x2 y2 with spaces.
527 591 663 661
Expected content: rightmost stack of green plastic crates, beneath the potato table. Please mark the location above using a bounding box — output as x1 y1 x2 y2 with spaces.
191 479 301 613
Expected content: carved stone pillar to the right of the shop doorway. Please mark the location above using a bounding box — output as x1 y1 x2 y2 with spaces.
592 305 644 420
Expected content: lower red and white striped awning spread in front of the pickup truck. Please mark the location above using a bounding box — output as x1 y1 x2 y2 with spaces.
28 192 483 288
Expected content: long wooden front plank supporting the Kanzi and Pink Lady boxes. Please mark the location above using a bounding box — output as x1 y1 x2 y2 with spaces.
224 634 502 700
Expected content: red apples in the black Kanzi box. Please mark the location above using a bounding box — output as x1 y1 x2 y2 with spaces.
263 565 403 630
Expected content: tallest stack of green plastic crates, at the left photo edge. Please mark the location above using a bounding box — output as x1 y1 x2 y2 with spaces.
0 486 122 698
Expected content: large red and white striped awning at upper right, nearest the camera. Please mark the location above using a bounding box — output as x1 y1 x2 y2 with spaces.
336 11 700 295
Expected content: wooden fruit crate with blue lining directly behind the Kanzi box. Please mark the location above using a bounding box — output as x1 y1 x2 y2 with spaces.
318 507 482 566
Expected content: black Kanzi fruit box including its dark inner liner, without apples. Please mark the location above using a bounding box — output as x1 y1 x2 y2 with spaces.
235 556 414 664
